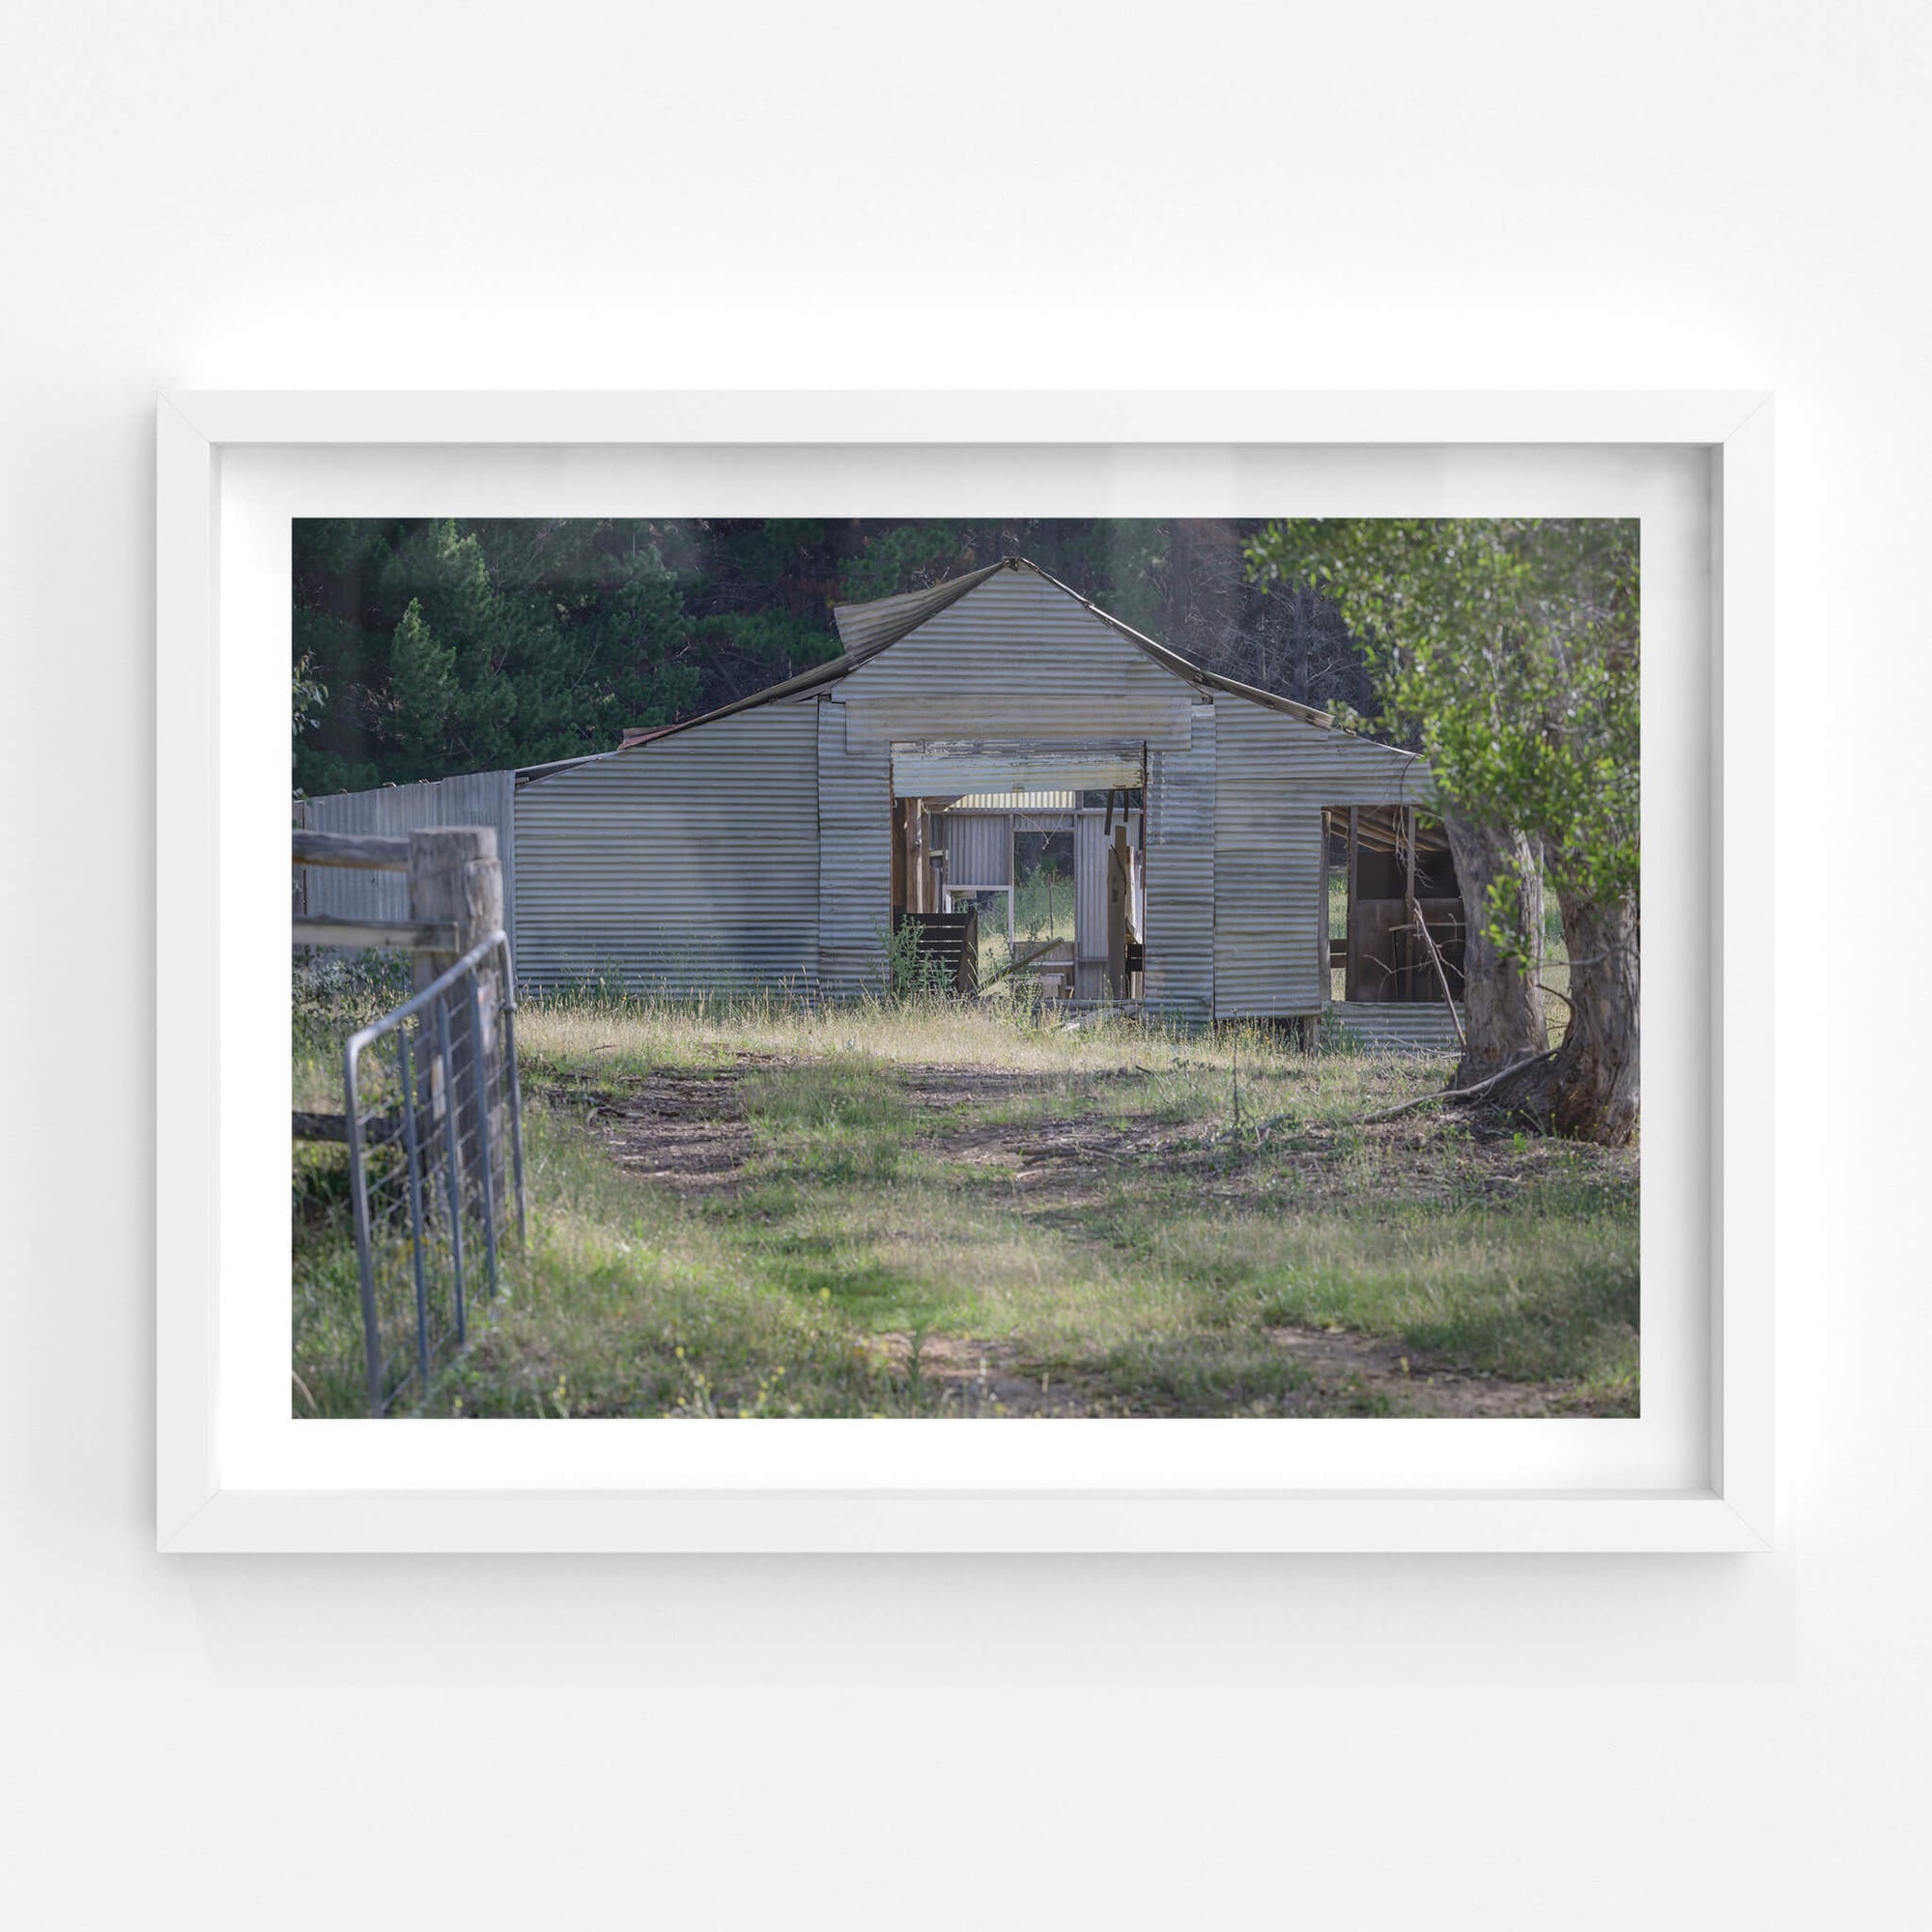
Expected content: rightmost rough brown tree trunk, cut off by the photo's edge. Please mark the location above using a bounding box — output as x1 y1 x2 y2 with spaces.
1490 893 1638 1148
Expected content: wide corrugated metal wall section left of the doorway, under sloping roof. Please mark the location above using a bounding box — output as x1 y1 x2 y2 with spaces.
516 703 819 995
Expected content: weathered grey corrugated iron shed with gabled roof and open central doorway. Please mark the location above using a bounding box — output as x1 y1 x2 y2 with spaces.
498 560 1430 1020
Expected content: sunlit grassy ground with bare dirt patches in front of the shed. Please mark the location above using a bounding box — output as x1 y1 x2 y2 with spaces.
296 987 1638 1416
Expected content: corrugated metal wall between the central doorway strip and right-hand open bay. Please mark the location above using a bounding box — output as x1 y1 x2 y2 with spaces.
1213 697 1428 1018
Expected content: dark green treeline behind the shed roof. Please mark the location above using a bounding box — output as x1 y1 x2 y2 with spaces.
294 518 1372 796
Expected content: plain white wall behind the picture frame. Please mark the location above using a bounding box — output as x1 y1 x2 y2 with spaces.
0 0 1932 1926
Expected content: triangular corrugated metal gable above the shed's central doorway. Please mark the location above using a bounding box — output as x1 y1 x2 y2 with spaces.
838 570 1192 746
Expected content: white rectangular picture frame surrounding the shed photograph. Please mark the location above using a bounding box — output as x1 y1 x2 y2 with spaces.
155 392 1777 1553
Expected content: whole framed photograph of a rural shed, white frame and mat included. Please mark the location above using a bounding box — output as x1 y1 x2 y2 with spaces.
156 392 1776 1551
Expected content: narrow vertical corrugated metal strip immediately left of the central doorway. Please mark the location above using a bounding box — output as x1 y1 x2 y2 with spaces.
815 699 898 995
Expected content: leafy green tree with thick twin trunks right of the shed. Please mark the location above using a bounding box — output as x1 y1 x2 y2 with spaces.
1248 518 1640 1146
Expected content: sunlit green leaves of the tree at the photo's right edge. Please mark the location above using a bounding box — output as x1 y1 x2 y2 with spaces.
1248 518 1640 951
